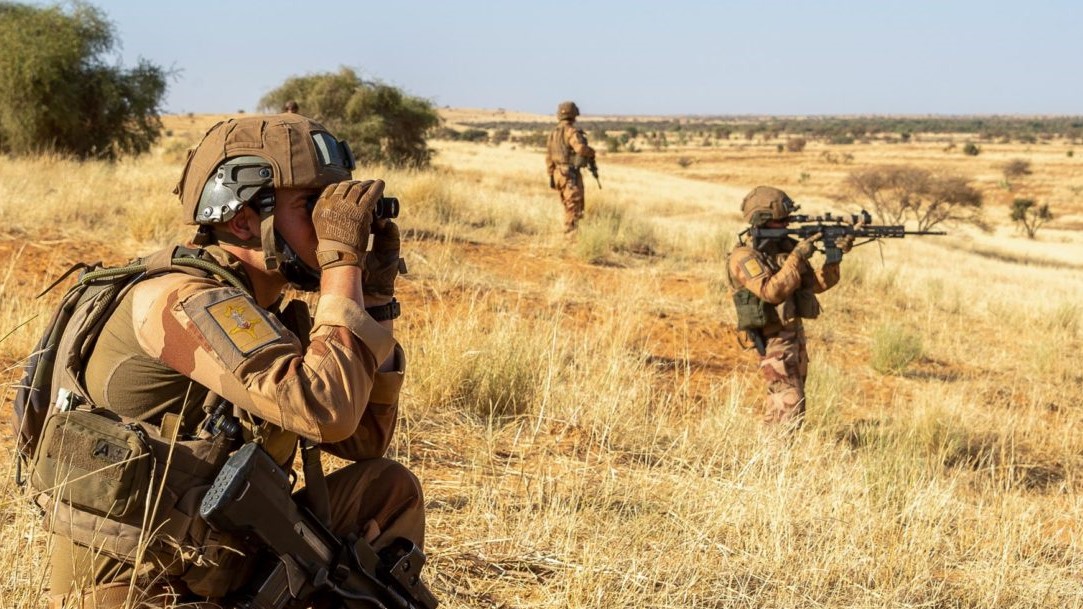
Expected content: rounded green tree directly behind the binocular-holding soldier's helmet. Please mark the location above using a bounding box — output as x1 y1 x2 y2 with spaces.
259 67 440 167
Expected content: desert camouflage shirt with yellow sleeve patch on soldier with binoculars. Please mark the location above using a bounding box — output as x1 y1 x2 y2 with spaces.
84 247 405 458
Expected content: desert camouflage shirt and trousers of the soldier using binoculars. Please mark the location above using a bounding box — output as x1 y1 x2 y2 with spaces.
42 115 425 609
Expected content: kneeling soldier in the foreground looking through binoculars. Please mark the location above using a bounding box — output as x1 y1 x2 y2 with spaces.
24 114 425 609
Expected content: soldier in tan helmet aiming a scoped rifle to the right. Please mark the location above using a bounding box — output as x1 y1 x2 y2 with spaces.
727 186 853 429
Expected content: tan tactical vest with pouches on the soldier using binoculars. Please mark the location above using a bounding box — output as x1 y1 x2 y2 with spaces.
13 248 275 597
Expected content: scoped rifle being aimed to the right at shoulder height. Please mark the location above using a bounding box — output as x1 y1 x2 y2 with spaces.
739 209 948 263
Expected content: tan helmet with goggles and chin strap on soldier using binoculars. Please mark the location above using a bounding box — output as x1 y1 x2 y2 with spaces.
173 114 355 289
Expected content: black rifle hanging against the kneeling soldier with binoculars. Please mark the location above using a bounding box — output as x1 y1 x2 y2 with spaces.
199 442 438 609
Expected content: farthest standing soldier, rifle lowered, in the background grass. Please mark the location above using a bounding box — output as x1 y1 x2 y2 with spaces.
545 102 595 233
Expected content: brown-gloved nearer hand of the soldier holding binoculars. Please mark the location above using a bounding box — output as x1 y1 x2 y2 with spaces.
312 180 383 269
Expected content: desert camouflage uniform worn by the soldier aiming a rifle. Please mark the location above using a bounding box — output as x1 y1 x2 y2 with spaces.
727 186 839 426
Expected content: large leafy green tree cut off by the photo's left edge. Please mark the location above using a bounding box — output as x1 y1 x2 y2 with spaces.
0 1 167 159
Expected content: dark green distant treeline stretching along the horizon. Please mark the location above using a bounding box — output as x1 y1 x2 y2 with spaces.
452 116 1083 144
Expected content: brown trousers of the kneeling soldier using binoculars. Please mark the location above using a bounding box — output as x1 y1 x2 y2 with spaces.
50 458 425 609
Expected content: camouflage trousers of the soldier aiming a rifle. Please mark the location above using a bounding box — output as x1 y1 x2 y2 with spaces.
759 325 809 426
